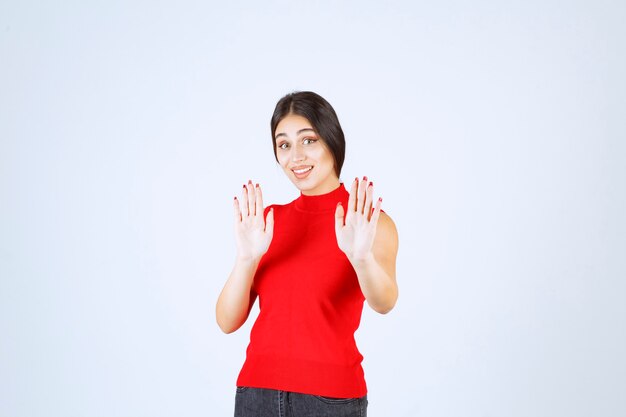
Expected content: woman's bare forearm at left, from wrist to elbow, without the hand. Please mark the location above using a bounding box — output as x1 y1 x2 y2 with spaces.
215 255 259 333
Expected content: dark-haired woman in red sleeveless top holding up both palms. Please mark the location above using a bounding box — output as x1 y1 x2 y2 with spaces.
216 92 398 417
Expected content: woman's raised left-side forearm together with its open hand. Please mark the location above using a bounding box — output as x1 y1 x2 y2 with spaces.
215 181 274 333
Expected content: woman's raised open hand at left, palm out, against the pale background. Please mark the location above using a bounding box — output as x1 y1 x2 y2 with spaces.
234 181 274 261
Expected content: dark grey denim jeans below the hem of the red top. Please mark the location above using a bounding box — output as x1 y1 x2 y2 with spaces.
235 387 367 417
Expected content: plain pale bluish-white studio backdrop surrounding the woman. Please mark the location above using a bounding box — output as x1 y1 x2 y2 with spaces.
0 0 626 417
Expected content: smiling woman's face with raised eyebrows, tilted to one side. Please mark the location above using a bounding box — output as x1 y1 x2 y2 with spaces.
274 114 339 195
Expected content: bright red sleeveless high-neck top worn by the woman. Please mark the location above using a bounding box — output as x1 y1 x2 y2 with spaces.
237 184 367 398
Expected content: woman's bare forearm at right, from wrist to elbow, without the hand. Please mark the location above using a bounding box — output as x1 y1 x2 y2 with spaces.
350 253 398 314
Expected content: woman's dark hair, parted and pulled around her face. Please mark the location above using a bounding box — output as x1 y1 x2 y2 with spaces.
270 91 346 177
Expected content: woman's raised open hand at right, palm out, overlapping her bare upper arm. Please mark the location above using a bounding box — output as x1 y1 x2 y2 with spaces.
335 177 382 262
